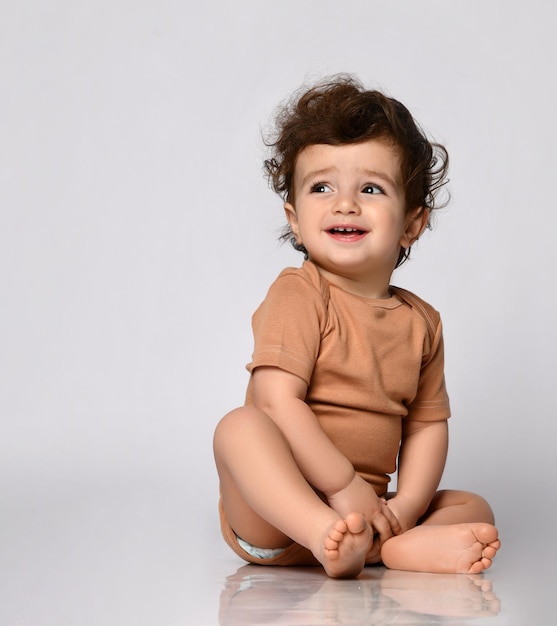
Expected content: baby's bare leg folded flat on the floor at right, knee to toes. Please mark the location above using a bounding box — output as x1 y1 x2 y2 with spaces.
381 491 501 574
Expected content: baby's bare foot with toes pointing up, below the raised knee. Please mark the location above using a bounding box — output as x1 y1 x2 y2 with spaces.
314 513 371 578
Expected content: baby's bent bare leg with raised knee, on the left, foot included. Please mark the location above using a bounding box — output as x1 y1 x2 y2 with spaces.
214 407 371 577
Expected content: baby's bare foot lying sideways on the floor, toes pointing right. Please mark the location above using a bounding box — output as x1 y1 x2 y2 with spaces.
381 522 501 574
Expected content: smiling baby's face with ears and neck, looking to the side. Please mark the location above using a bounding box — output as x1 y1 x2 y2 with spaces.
285 140 427 297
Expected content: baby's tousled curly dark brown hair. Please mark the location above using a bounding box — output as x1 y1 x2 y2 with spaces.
264 74 449 267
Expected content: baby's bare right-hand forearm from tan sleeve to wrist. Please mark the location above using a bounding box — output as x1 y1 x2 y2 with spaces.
389 420 449 530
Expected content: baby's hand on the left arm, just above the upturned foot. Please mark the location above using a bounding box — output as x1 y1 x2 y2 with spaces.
327 474 402 543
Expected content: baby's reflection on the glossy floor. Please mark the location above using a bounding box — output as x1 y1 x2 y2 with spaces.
219 565 500 626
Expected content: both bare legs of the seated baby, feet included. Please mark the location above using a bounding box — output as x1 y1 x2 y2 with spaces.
214 407 500 578
